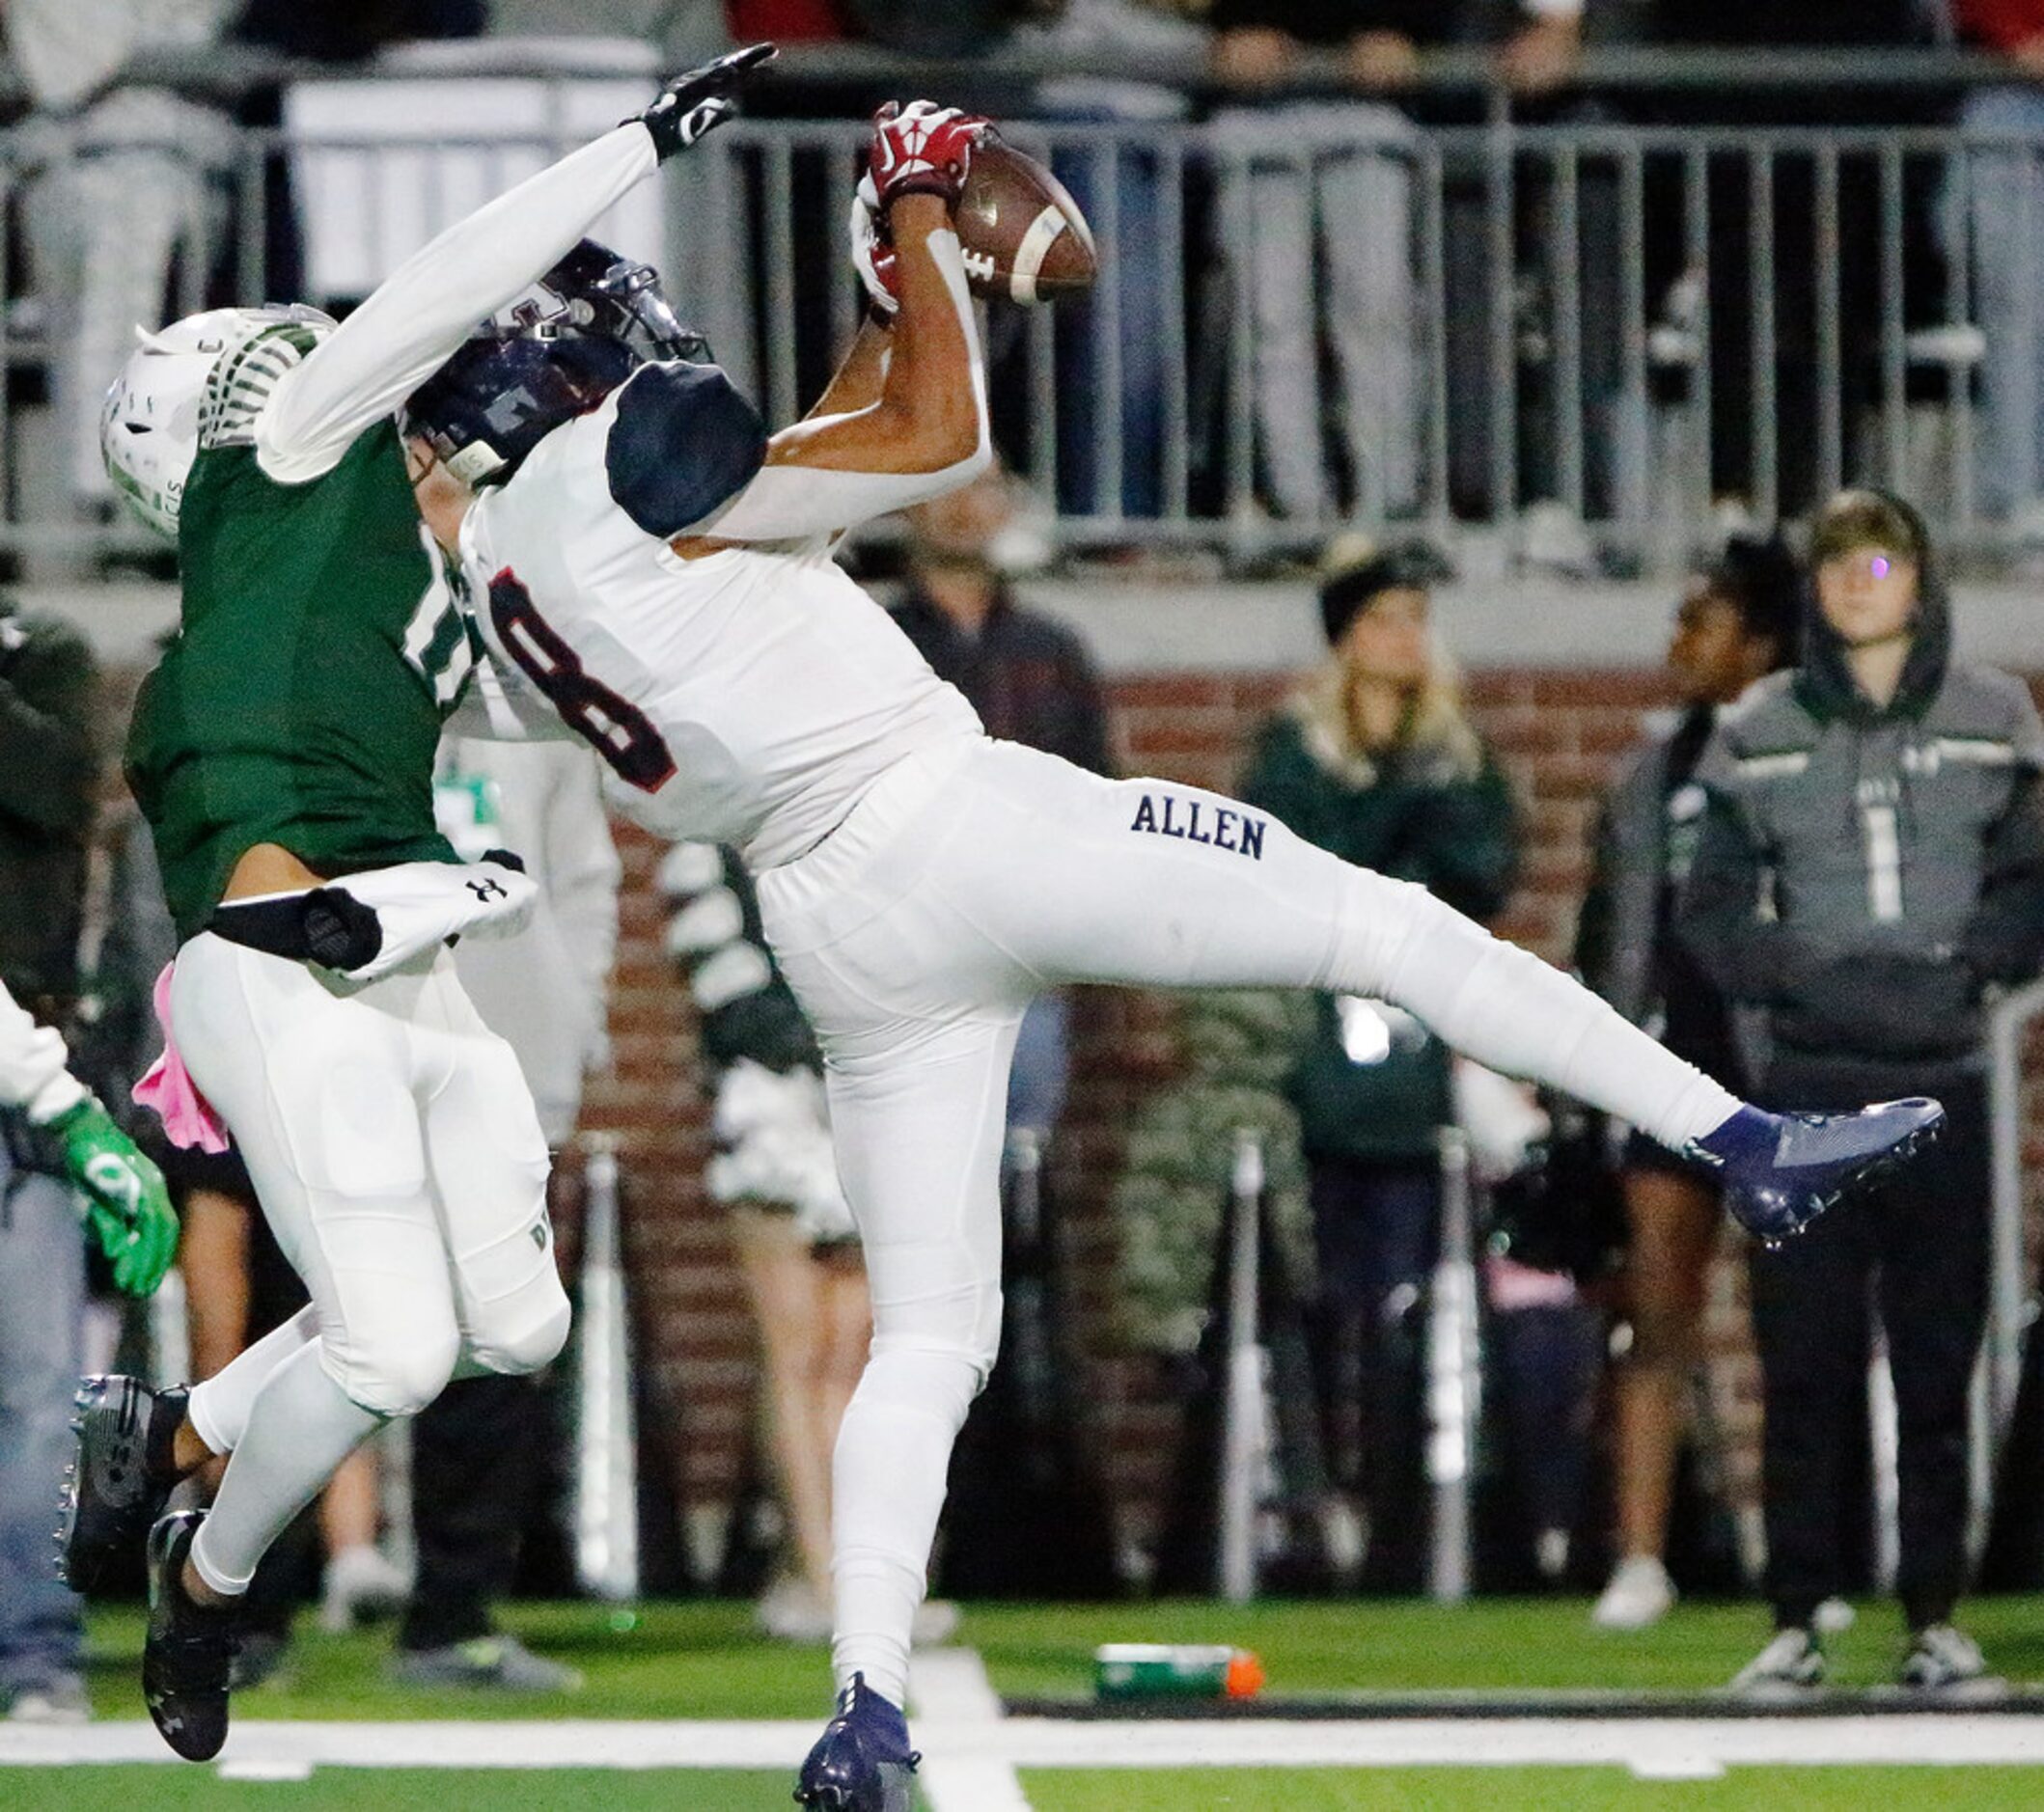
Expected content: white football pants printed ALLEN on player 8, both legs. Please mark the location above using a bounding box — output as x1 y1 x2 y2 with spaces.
759 742 1739 1704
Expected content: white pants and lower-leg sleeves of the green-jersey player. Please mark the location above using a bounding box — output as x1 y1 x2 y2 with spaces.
170 931 568 1591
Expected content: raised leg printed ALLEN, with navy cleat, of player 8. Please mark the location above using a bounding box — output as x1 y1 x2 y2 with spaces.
927 744 1940 1240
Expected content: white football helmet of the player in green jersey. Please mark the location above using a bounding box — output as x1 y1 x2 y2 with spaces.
100 302 333 539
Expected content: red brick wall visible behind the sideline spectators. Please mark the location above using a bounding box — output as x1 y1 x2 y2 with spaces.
566 673 1782 1560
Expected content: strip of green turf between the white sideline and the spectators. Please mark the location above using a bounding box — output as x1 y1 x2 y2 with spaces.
71 1598 2044 1720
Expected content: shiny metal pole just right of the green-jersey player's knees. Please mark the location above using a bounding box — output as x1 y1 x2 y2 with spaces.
574 1132 640 1600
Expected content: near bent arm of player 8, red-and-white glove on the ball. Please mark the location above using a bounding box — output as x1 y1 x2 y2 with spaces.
695 102 993 541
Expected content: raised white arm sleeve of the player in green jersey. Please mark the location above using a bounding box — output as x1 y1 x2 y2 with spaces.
256 121 658 484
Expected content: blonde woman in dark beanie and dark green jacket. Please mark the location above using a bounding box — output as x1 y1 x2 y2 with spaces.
1243 541 1519 1589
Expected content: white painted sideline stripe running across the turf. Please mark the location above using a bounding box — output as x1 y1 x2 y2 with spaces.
12 1716 2044 1789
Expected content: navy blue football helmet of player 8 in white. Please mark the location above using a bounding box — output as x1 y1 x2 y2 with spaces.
402 239 709 484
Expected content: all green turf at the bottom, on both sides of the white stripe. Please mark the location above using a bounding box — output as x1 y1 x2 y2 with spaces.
0 1598 2044 1812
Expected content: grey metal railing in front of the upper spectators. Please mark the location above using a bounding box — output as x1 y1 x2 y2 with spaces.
12 51 2044 570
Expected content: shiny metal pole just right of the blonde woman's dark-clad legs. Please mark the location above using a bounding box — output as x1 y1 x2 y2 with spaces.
1426 1126 1484 1604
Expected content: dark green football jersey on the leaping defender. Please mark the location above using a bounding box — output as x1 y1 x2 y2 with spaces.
126 423 474 938
